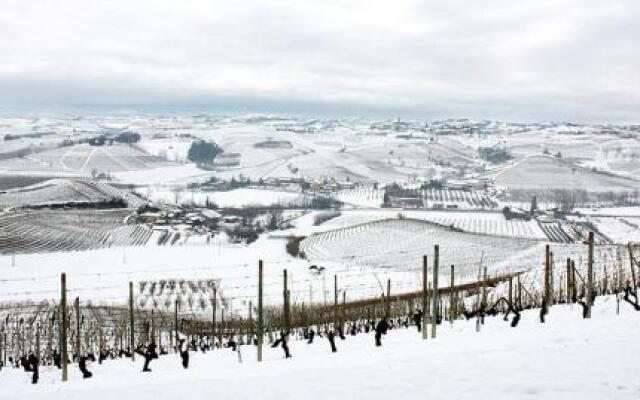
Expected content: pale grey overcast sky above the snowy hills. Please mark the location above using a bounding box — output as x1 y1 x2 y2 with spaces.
0 0 640 121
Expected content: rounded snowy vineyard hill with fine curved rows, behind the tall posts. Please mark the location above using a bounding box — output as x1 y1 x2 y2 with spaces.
300 219 596 288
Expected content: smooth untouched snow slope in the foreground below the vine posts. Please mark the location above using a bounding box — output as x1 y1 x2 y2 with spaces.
0 296 640 400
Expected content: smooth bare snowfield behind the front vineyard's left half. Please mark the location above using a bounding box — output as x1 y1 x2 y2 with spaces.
0 235 308 311
